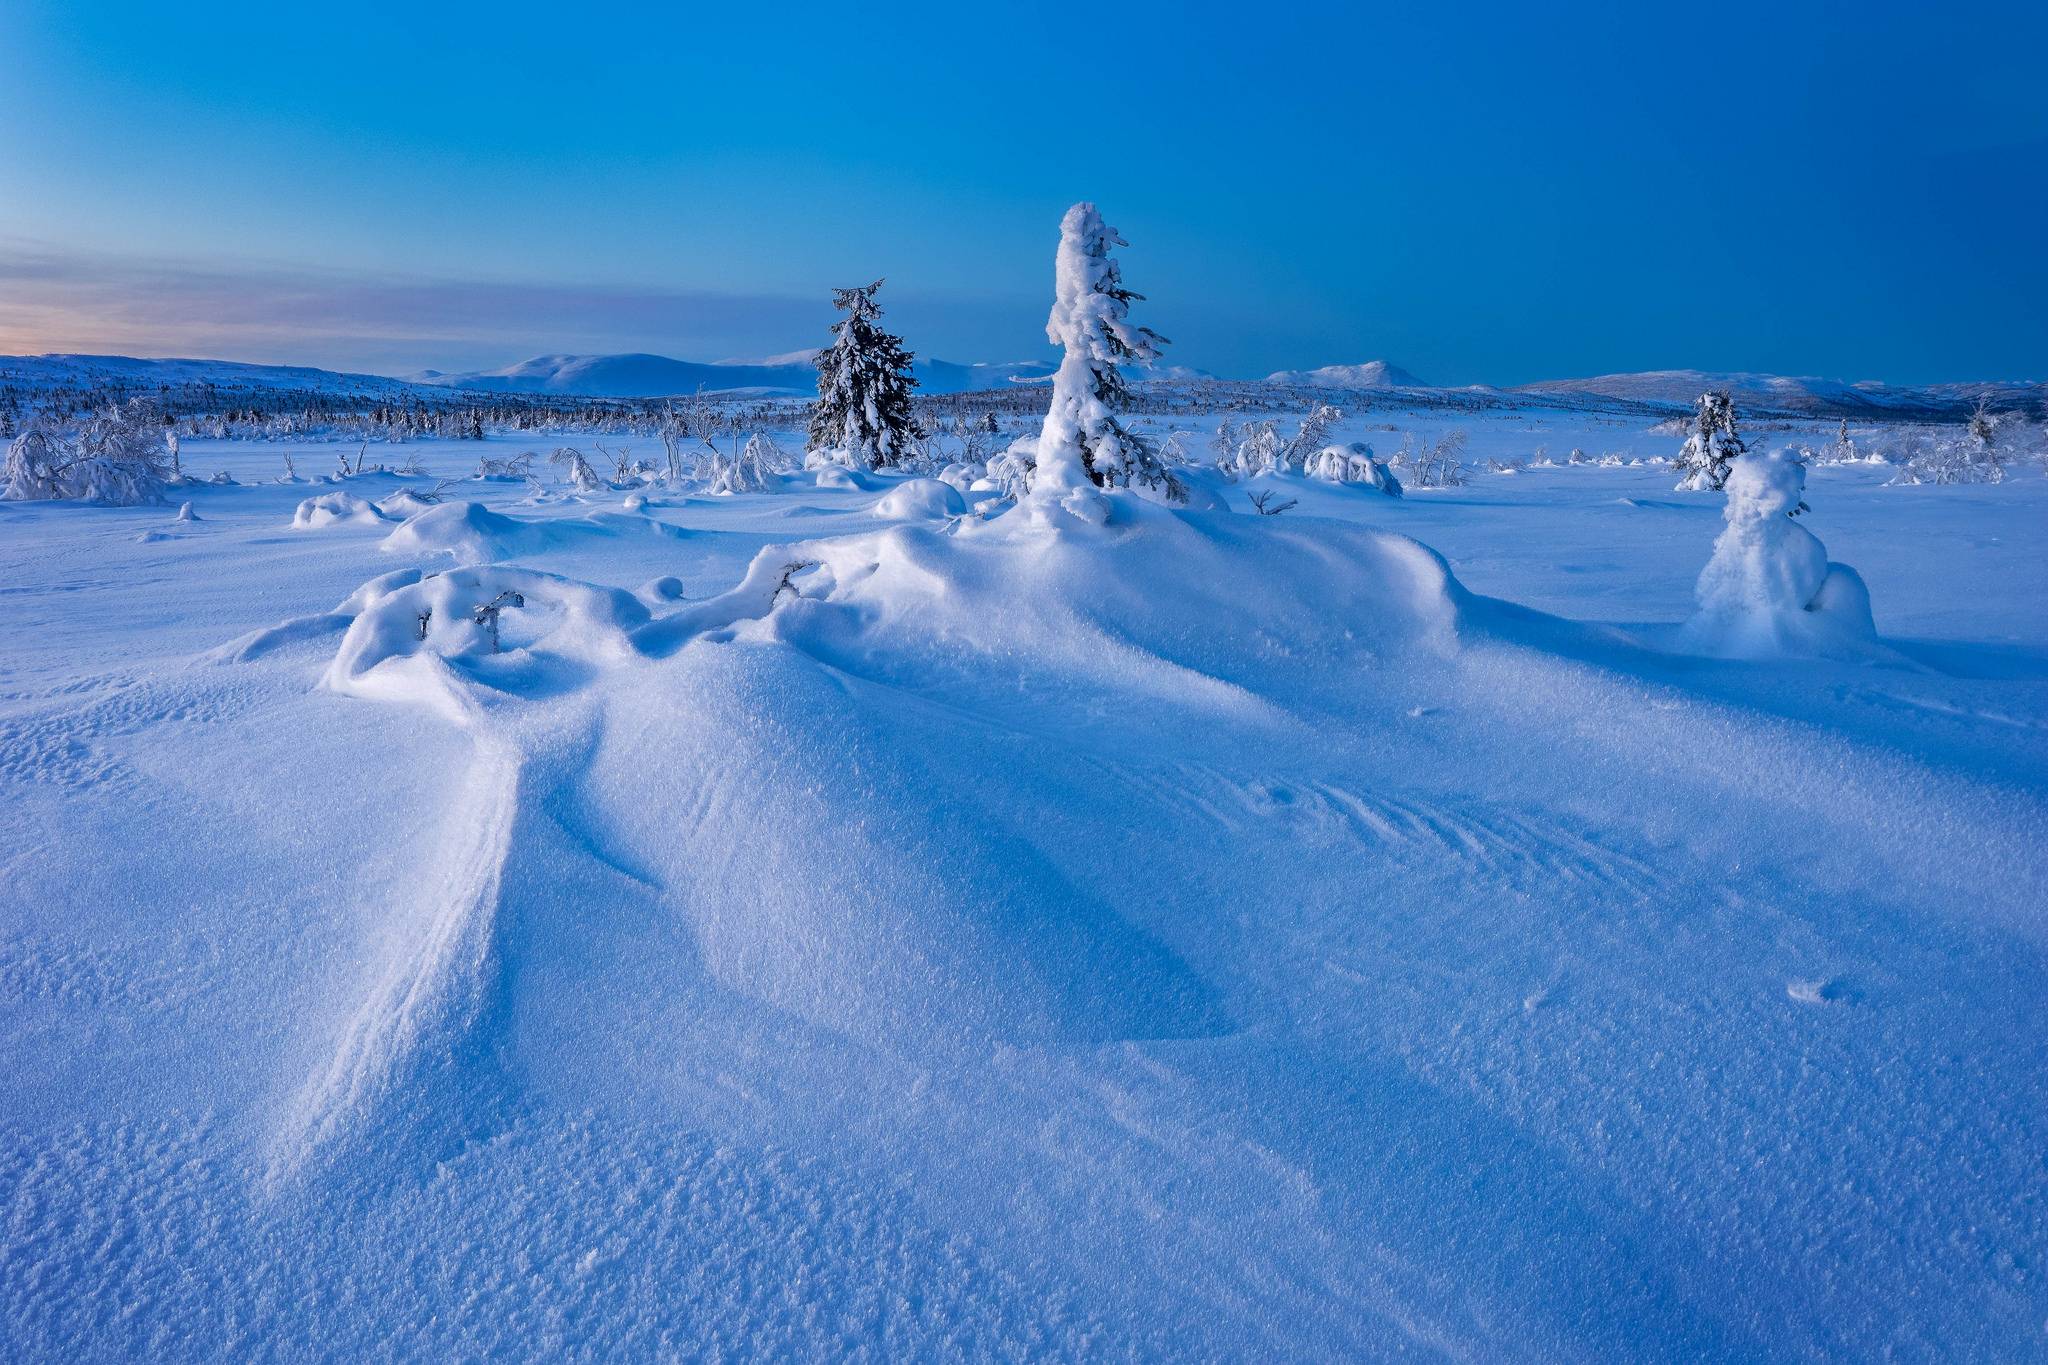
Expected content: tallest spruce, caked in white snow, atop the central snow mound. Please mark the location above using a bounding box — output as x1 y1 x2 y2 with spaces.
1032 203 1188 505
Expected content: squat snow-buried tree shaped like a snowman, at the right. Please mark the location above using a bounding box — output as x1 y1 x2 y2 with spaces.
1681 450 1880 659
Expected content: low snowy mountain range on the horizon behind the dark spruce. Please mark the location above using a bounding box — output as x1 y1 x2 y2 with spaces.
412 350 1053 399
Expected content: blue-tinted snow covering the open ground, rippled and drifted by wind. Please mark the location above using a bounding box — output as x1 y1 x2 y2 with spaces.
0 419 2048 1359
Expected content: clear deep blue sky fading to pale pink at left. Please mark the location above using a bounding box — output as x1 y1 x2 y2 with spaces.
0 0 2048 383
